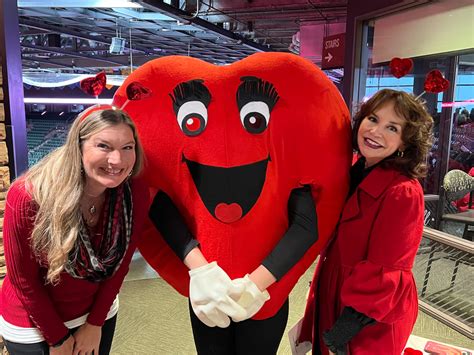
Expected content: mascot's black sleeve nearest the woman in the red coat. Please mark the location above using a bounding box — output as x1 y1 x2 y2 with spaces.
262 186 318 280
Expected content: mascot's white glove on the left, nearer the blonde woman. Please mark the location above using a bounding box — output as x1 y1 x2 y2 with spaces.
189 261 247 328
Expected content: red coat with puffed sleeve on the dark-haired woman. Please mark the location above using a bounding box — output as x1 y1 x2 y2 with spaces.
300 167 424 355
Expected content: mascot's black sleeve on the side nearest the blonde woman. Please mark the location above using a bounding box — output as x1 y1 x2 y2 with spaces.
148 191 199 260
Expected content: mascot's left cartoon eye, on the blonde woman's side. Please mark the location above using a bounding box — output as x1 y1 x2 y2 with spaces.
176 101 207 137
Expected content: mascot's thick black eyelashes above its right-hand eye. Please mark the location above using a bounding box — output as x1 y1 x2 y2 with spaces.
237 76 280 111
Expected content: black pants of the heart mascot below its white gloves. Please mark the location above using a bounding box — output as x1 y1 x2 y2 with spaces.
189 300 288 355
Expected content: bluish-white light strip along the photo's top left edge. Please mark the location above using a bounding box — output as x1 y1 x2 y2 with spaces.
18 0 143 8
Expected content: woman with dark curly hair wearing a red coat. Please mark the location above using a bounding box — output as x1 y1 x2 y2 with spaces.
299 89 433 355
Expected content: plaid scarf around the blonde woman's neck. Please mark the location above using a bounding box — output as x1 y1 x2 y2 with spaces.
65 182 133 282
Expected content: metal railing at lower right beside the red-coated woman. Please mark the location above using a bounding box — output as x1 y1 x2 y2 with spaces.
413 227 474 339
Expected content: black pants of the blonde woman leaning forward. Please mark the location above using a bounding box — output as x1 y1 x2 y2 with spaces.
4 315 117 355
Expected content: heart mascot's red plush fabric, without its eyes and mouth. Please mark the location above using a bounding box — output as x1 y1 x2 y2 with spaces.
114 53 351 319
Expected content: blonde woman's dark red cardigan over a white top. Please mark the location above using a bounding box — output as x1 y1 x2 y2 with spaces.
0 180 149 344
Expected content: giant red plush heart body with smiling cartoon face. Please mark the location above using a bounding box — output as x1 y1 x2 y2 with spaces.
114 53 351 319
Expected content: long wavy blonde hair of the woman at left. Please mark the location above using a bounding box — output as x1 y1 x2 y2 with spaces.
25 109 143 284
